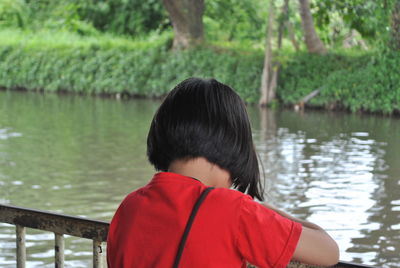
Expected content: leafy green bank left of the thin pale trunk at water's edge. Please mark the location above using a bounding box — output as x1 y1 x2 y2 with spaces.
0 32 263 102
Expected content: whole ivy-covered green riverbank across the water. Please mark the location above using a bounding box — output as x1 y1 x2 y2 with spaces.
0 30 400 114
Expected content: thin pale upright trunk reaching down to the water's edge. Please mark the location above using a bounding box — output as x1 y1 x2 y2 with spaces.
259 0 275 107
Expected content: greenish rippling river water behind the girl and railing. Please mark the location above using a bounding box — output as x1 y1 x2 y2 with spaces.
0 91 400 267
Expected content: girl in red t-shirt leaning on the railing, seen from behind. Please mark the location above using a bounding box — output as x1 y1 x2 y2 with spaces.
107 78 339 268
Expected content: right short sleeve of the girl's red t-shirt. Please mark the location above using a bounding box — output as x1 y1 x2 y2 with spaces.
237 196 302 268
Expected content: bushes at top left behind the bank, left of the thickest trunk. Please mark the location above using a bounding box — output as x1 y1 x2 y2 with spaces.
0 0 169 35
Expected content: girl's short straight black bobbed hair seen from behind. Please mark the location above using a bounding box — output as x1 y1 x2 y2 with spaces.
147 78 264 200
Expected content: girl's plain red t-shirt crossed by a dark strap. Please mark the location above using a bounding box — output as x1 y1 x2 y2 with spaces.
107 172 302 268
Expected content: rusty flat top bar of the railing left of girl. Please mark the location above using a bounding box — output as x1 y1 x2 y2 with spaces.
0 204 109 242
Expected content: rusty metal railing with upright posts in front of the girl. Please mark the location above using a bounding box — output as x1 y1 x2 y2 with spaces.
0 204 377 268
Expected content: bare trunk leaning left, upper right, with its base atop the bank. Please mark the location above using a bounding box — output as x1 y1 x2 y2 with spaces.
299 0 326 54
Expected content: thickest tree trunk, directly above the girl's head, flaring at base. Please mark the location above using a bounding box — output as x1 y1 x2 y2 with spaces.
163 0 204 49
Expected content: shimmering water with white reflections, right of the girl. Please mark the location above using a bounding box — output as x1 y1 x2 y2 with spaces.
253 108 400 267
